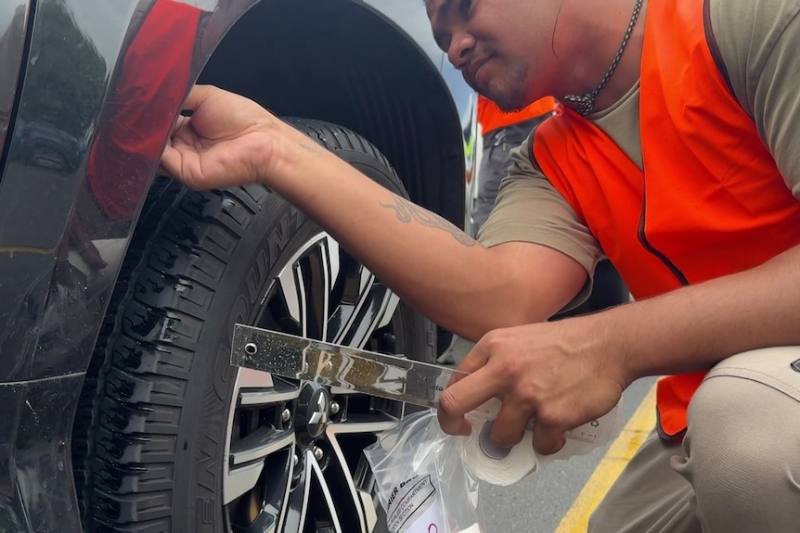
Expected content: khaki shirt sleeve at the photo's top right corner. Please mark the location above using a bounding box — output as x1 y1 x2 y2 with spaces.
708 0 800 199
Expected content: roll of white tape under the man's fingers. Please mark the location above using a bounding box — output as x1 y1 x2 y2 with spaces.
462 420 537 486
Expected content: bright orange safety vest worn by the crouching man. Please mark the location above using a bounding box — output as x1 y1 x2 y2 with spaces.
533 0 800 439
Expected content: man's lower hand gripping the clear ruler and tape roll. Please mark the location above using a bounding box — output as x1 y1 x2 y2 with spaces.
439 317 629 454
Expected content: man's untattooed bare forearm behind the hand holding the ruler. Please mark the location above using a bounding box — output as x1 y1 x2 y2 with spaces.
579 247 800 380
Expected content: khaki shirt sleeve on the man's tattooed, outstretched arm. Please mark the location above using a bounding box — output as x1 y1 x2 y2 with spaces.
478 131 602 311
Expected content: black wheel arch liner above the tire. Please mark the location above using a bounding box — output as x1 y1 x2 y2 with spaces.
199 0 471 227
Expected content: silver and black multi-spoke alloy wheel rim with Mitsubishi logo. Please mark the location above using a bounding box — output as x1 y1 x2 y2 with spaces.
222 232 403 533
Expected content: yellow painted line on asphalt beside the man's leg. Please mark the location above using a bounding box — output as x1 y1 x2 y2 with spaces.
556 385 656 533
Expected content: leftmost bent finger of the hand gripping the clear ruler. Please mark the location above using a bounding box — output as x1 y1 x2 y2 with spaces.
438 369 499 435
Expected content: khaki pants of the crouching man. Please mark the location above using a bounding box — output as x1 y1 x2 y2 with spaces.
589 347 800 533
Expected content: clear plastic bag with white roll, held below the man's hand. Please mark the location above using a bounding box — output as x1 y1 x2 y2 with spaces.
364 398 622 533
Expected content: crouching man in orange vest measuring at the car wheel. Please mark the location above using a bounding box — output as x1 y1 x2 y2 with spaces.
163 0 800 533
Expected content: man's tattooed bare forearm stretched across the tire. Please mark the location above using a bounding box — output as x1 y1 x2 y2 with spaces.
268 130 580 339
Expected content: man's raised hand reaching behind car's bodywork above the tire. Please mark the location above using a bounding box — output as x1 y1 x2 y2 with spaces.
161 85 297 189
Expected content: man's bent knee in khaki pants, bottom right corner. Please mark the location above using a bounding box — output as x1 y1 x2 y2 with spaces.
674 348 800 531
